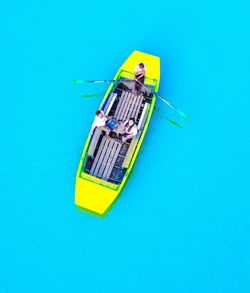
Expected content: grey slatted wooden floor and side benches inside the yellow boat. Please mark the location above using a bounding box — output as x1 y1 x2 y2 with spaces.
84 81 151 184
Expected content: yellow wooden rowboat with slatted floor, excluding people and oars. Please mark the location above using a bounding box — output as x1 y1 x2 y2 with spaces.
75 51 160 216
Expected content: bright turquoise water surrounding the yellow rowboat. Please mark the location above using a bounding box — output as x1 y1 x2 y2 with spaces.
0 0 250 293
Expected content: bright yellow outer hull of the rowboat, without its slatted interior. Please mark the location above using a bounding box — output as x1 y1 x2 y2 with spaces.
75 51 160 216
